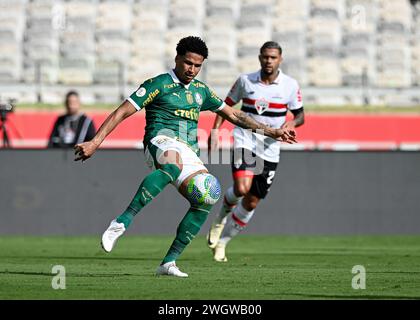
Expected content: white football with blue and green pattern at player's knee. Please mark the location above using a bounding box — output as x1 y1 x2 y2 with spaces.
187 173 222 204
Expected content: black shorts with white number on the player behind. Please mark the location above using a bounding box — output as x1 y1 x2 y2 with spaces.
232 148 278 199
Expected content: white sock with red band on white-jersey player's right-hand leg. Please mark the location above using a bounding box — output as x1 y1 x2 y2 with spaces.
219 202 255 245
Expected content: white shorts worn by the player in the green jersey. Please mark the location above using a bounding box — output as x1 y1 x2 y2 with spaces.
144 135 207 189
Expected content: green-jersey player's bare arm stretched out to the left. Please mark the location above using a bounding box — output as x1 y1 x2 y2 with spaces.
74 101 137 161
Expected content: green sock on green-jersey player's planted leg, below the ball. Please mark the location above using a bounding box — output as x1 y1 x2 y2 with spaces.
162 205 212 264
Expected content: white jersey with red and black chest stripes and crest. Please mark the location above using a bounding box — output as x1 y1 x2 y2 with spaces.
225 70 303 162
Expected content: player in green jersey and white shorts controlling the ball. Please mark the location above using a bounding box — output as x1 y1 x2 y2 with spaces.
75 36 296 277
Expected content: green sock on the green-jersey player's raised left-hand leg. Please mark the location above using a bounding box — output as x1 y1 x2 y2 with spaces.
117 164 181 229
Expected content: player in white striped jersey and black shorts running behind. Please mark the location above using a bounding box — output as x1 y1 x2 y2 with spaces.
207 41 304 262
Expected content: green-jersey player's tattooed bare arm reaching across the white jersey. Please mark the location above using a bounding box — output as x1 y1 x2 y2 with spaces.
217 105 297 143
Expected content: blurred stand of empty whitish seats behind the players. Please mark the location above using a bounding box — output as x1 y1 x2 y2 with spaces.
0 0 420 105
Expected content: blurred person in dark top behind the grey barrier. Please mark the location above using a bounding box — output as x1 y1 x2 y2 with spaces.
48 91 96 148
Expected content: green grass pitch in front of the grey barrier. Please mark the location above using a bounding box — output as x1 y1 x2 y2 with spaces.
0 235 420 300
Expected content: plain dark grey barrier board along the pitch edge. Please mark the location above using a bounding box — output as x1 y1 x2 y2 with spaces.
0 149 420 235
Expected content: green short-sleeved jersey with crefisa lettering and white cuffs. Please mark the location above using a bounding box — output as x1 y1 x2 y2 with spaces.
127 70 223 155
